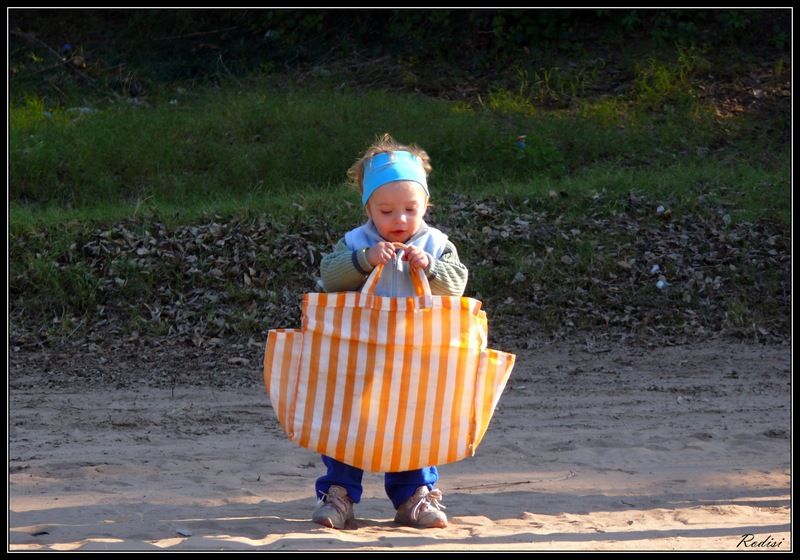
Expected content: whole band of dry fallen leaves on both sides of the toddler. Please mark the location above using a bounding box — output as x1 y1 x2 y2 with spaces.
9 196 791 349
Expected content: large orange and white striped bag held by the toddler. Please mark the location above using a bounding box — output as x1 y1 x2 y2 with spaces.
264 260 515 472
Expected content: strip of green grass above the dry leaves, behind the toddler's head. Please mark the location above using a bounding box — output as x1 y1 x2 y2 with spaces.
10 74 790 225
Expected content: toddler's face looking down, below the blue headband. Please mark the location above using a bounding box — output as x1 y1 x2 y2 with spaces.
366 181 428 243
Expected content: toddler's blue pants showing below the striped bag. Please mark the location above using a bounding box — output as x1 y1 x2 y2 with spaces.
317 455 439 509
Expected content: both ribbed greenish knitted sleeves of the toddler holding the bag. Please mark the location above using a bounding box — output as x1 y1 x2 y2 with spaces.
320 239 469 296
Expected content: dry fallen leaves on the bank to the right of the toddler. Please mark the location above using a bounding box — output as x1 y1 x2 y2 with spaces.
437 195 791 344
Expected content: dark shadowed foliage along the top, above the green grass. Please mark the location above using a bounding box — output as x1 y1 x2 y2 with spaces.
9 9 791 94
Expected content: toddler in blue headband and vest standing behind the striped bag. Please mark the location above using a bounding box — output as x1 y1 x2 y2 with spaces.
312 134 467 529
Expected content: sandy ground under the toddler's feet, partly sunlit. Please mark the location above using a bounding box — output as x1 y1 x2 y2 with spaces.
8 341 792 551
